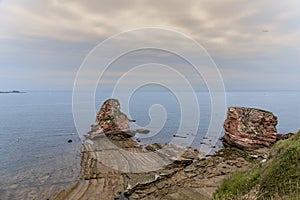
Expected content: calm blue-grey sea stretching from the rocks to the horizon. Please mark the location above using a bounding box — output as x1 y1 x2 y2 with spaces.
0 91 300 199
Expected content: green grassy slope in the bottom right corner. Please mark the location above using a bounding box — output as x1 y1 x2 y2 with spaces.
214 131 300 200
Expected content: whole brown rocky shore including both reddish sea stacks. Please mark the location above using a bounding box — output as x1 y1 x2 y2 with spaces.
51 99 296 200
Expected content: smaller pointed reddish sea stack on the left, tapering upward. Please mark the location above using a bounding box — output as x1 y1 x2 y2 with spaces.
96 99 129 133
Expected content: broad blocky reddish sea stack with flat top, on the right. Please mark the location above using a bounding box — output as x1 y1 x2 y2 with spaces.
223 107 278 150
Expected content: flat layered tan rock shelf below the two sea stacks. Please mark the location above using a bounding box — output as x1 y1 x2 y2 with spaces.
51 131 258 200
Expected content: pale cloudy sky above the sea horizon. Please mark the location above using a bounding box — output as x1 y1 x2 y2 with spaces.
0 0 300 91
